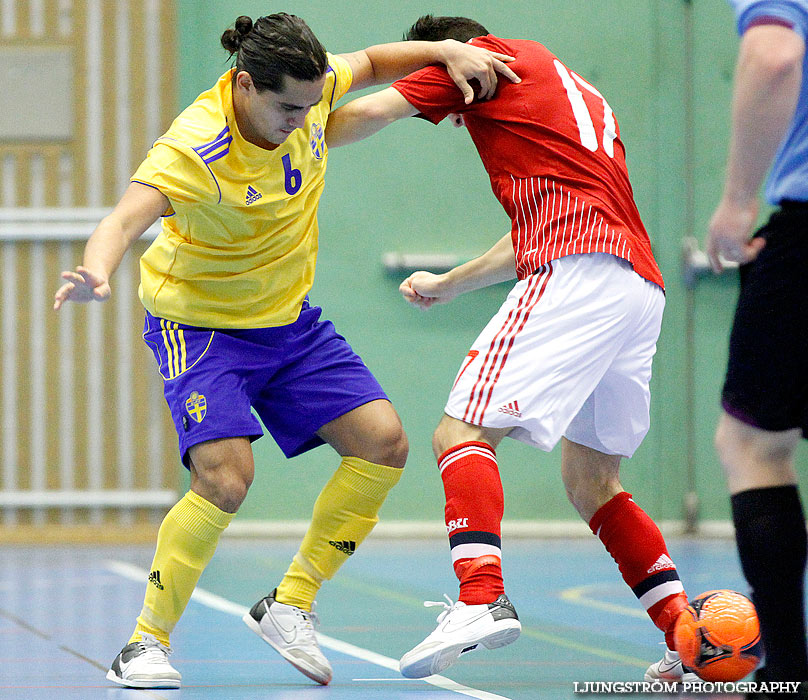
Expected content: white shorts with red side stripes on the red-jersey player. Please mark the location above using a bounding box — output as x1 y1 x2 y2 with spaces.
444 253 665 457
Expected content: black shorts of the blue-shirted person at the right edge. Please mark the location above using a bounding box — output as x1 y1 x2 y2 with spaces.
721 202 808 437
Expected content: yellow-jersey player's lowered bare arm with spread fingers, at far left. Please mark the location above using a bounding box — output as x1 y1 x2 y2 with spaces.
53 182 170 310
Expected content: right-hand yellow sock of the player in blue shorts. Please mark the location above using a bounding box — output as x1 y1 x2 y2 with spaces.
276 457 403 610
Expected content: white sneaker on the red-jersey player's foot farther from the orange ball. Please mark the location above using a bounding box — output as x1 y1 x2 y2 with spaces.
399 593 522 678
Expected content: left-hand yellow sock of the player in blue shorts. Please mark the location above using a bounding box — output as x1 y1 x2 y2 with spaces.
129 491 234 646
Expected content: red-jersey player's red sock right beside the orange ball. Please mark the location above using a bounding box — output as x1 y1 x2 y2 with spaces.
589 491 687 649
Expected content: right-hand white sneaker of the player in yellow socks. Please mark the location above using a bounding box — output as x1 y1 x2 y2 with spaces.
242 588 331 685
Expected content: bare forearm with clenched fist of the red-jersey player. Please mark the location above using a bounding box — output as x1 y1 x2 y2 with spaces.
399 233 516 310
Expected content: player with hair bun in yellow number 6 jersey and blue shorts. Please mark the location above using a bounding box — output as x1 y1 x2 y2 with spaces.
54 13 515 688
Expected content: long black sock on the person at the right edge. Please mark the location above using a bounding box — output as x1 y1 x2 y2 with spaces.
731 486 808 681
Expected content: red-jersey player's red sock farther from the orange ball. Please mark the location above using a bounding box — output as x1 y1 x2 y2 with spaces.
438 442 505 605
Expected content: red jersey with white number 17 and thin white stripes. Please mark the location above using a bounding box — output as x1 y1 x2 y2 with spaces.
393 34 664 287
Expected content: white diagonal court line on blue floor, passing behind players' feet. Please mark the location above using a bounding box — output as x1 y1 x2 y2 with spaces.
104 560 509 700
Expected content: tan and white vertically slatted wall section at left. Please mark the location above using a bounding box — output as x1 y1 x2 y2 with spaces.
0 0 183 535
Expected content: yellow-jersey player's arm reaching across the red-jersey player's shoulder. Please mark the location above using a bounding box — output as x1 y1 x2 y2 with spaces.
342 39 521 104
